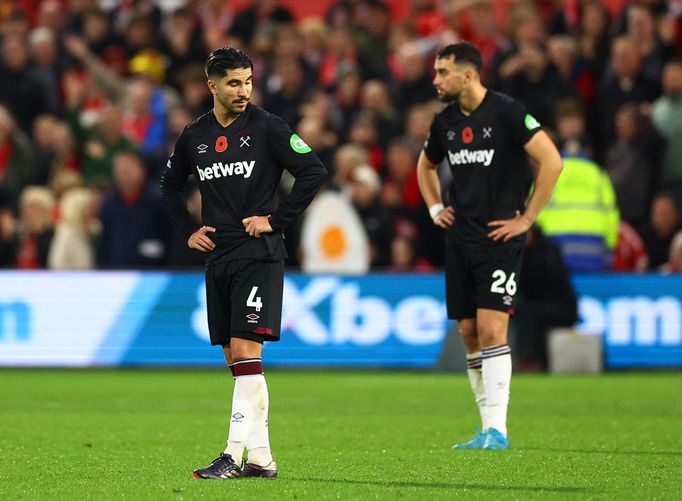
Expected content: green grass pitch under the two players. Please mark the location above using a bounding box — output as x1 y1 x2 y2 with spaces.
0 369 682 501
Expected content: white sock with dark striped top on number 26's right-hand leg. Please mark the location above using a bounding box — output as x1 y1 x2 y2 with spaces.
481 344 511 436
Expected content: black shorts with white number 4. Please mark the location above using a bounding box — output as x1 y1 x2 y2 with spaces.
206 259 284 346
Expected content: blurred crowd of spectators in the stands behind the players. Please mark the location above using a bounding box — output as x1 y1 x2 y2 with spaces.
0 0 682 272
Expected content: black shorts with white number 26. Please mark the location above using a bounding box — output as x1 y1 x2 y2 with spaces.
445 242 523 320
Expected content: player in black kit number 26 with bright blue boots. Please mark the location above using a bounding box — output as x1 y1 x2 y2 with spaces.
417 42 562 449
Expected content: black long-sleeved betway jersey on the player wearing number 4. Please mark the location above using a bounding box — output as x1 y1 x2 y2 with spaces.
161 104 327 263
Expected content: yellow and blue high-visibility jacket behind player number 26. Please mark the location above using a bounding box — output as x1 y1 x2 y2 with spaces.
537 157 620 271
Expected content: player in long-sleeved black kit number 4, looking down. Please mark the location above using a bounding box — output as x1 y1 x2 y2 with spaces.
161 47 327 479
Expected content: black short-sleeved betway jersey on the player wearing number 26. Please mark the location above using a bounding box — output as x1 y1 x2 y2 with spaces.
424 90 541 246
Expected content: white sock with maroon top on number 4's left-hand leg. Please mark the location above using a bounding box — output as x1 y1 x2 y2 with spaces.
224 359 265 464
